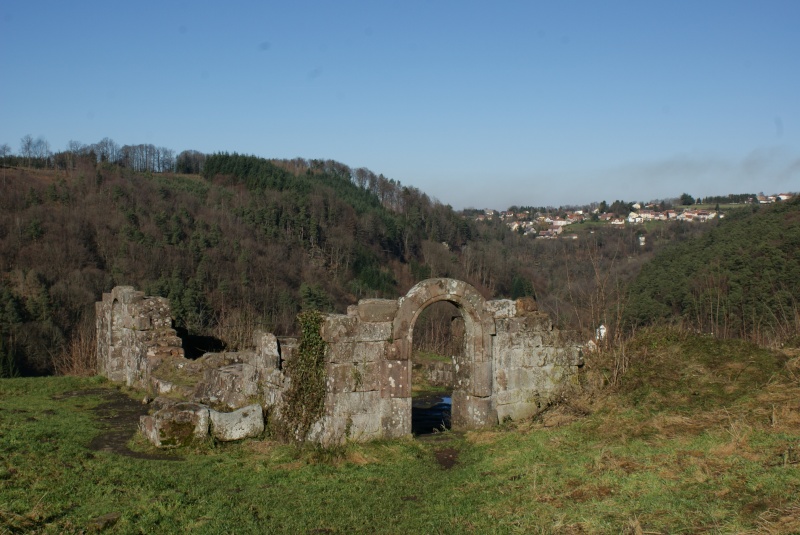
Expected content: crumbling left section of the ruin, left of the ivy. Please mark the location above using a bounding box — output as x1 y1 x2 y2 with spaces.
96 286 293 447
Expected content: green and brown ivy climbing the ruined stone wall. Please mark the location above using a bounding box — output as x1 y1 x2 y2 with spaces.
283 310 326 442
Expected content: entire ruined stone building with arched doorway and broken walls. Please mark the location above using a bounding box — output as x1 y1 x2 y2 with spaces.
96 278 583 446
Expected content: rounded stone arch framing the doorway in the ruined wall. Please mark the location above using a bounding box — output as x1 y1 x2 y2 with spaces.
392 278 497 433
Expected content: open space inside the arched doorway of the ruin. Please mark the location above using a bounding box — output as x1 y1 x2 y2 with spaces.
411 301 464 435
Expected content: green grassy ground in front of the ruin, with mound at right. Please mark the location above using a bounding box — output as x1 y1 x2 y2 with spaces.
0 331 800 534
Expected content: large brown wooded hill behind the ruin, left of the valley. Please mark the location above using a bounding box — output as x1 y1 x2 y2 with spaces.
0 154 532 374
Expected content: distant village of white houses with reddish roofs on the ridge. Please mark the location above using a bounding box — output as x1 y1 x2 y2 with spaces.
475 193 794 239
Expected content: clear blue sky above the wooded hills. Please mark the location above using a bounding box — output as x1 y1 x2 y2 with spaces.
0 0 800 209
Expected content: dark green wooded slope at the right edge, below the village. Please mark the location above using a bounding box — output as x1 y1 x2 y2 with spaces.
624 198 800 344
